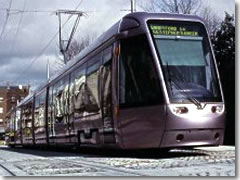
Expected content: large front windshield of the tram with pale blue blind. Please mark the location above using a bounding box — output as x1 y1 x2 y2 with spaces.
149 21 222 103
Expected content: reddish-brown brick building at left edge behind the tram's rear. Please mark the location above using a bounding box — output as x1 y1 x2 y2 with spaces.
0 85 29 140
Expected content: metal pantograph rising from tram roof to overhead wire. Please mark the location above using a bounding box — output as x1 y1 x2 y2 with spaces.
56 10 84 64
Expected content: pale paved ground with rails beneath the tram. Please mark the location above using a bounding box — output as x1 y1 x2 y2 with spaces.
0 146 235 176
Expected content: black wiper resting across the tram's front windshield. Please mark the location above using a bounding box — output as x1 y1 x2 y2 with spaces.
167 62 202 109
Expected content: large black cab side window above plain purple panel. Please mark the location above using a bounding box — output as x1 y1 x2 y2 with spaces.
119 35 163 107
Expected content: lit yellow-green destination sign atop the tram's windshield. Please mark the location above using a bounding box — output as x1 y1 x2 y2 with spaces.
150 25 199 36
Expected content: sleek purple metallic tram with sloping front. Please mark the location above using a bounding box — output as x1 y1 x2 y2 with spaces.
8 12 225 149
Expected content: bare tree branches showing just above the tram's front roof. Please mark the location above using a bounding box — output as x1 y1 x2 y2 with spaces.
139 0 202 14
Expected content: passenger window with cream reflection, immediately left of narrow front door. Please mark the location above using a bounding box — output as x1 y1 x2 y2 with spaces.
84 56 100 113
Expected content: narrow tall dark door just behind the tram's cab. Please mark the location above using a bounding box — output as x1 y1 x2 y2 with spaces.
101 46 115 144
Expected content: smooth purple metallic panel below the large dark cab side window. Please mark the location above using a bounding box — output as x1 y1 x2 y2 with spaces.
117 106 166 149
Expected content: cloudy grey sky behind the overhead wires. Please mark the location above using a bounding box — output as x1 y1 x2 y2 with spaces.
0 0 235 91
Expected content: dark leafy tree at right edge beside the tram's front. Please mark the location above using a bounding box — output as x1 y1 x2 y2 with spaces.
212 13 235 145
